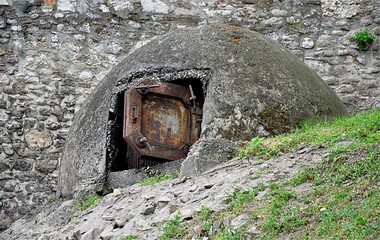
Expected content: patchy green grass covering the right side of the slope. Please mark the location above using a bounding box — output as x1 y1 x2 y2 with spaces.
178 109 380 240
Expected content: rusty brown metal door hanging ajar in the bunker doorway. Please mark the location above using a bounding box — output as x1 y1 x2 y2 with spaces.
123 80 202 168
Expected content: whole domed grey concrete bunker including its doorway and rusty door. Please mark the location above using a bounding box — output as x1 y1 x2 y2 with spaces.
58 24 347 197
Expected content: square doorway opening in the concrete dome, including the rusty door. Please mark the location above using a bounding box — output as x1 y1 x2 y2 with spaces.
107 79 204 172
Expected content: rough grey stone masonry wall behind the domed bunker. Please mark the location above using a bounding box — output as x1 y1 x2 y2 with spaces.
0 0 380 230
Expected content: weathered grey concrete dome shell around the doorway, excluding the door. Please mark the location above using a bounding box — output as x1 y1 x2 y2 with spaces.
59 25 347 196
